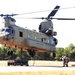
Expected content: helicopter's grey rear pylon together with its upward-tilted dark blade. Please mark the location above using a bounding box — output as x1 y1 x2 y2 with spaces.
39 6 60 33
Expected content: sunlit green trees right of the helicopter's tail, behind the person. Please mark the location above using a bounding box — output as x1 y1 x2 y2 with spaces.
56 44 75 61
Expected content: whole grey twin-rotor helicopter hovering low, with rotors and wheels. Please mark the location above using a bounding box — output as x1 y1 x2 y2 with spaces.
0 6 75 65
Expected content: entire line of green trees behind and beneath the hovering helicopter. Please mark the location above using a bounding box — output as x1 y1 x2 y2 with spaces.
0 44 75 61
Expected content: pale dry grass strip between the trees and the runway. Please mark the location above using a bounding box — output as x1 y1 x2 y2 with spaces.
0 60 75 66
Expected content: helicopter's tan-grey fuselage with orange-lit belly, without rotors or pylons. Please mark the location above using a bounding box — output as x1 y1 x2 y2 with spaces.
0 25 56 52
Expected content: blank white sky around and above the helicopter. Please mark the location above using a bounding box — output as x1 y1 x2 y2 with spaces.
0 0 75 47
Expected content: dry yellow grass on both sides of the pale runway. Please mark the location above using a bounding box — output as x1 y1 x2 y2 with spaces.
0 61 75 75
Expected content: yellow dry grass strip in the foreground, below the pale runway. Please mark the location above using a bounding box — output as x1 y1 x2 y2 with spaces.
0 71 75 75
